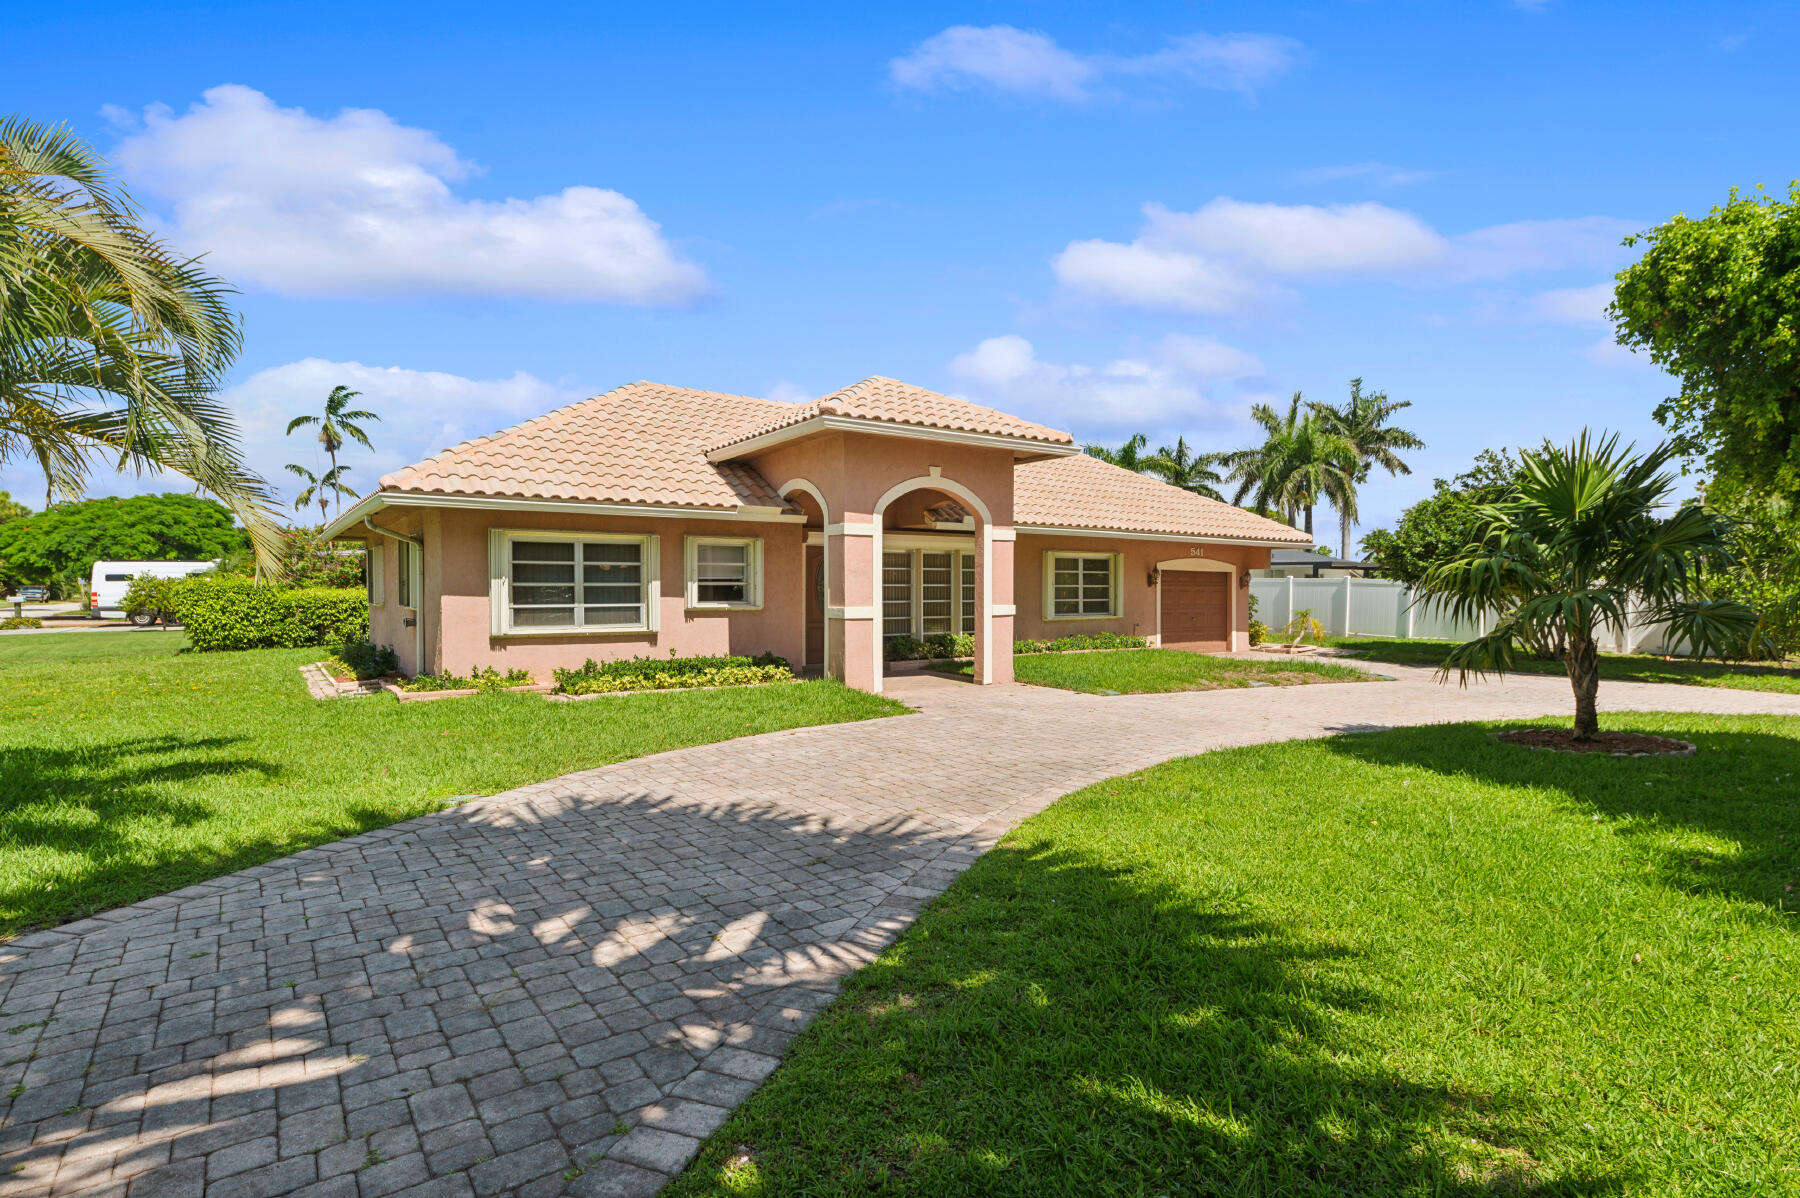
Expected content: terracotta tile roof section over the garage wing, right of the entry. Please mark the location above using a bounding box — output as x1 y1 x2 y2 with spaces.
1013 453 1312 545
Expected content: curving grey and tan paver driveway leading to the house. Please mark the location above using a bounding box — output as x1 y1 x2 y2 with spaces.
10 667 1800 1198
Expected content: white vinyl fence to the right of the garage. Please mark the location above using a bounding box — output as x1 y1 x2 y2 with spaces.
1249 576 1669 653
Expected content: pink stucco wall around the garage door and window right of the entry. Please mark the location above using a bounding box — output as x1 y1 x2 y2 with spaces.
1013 532 1269 648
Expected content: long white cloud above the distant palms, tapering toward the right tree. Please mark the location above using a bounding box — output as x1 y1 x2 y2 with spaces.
1051 196 1633 313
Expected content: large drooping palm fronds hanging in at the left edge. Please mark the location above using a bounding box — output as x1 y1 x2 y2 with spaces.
0 117 279 563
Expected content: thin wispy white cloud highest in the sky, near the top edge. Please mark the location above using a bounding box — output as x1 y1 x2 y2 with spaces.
887 25 1300 101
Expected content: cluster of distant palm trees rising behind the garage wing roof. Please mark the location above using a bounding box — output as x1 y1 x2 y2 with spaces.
1084 378 1426 558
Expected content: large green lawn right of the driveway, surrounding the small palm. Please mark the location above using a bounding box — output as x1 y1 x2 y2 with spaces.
666 716 1800 1198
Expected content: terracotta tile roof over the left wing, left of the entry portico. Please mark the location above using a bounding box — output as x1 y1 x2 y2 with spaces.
382 383 794 509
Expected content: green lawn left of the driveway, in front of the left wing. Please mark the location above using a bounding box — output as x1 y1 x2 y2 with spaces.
0 631 905 935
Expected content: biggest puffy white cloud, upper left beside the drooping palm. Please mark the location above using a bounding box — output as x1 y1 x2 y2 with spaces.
113 85 707 304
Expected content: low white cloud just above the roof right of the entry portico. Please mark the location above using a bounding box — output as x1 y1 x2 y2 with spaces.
950 333 1262 441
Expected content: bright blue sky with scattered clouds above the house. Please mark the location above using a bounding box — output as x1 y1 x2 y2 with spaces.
0 0 1800 540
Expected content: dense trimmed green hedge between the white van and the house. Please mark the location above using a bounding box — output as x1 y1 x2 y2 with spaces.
171 576 369 653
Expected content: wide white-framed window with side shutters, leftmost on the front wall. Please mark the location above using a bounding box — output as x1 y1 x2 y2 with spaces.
491 532 655 635
